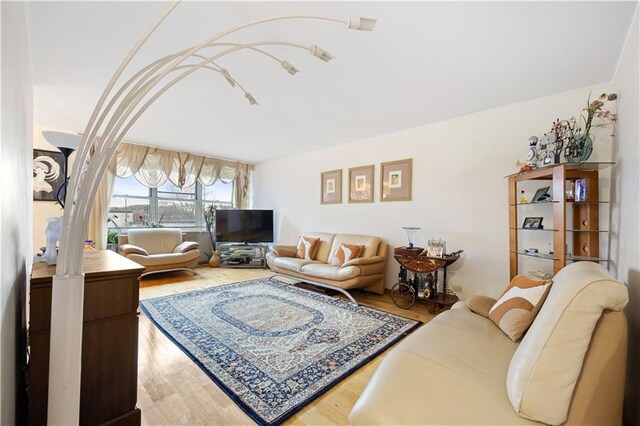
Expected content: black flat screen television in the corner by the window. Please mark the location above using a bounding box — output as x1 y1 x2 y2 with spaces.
216 210 273 243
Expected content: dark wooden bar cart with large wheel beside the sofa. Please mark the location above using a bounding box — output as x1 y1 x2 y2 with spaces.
391 247 464 315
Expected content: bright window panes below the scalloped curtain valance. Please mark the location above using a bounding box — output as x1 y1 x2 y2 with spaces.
109 176 233 228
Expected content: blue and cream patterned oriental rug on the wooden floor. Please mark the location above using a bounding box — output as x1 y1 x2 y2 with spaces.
140 279 420 425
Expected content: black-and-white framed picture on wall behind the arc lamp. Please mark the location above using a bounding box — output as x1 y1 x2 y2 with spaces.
33 149 66 201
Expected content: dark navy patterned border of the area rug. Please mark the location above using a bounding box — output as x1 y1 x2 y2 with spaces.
139 278 424 426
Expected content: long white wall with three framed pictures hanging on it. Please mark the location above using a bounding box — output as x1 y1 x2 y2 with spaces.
253 83 611 297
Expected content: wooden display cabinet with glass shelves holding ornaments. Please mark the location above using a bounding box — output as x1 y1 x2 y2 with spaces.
507 163 613 278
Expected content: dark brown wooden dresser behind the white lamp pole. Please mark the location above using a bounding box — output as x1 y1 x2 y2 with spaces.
27 250 144 425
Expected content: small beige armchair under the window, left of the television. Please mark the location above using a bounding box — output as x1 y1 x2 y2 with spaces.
118 228 200 277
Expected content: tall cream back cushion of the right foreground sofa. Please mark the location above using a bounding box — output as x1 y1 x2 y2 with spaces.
507 262 629 425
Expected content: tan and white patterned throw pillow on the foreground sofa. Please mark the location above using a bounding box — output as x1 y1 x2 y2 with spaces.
489 275 553 342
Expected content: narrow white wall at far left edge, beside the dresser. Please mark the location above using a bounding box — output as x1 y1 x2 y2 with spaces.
0 2 33 425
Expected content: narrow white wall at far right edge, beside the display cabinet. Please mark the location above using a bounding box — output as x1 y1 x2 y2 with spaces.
612 5 640 425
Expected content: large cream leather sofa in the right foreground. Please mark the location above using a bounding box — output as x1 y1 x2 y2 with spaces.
349 262 628 425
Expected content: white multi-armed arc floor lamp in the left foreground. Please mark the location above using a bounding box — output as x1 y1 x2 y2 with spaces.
48 2 376 425
